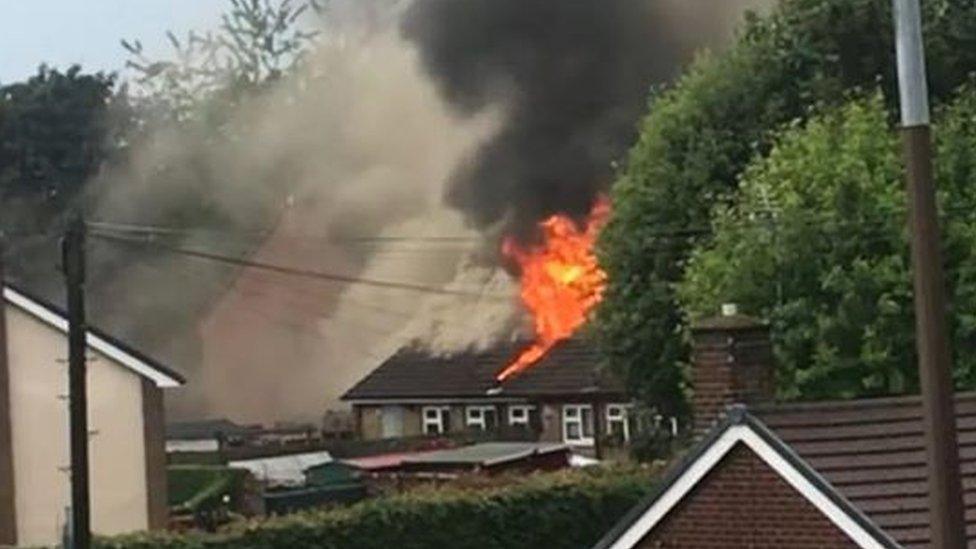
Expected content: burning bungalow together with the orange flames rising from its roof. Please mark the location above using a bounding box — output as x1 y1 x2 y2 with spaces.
342 198 631 446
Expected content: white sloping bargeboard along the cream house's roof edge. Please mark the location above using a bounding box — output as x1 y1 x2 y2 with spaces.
2 284 186 388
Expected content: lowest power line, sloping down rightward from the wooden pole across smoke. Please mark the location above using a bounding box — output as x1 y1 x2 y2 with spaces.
91 232 509 300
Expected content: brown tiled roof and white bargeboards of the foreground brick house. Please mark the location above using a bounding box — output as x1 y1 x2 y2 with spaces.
597 393 976 548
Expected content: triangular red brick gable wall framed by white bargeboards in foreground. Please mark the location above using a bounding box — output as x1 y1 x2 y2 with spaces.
638 444 856 549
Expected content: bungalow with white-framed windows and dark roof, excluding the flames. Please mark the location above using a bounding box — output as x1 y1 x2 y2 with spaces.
342 339 632 447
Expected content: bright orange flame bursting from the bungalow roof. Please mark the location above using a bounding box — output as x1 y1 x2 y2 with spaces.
497 196 610 381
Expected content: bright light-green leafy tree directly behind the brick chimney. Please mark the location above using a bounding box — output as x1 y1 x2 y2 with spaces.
678 89 976 399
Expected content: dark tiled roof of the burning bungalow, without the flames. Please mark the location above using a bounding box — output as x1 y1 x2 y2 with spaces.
342 338 625 400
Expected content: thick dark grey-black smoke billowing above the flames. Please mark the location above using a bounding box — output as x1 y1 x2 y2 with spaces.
402 0 761 236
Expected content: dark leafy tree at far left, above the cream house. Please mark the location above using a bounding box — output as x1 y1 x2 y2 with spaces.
0 66 120 229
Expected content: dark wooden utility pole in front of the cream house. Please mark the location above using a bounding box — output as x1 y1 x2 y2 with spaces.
61 215 91 549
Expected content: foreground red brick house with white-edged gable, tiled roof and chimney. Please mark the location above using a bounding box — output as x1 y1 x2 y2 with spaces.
596 315 976 549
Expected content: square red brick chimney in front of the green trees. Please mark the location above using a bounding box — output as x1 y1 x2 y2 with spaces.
692 305 775 434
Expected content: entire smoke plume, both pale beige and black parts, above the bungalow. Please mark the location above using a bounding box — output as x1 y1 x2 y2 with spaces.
70 0 764 421
